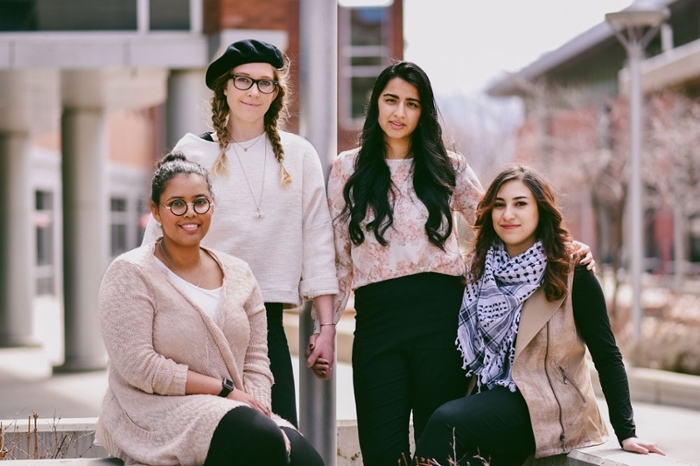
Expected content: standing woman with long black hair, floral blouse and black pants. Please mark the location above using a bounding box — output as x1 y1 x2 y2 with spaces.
328 62 482 466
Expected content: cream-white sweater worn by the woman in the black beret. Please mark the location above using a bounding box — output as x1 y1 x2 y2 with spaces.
143 131 338 305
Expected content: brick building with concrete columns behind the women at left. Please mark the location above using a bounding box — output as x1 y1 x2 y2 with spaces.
0 0 403 370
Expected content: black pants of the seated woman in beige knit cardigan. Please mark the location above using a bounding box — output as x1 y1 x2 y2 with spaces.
204 406 324 466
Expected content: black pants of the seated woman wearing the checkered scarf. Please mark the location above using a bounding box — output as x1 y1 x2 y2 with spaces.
416 387 535 466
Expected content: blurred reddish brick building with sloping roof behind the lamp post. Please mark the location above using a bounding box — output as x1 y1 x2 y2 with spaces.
488 0 700 272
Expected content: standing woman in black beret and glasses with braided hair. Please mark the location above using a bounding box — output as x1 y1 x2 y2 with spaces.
144 39 338 425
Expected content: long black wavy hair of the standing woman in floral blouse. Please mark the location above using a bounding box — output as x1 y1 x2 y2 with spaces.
341 61 455 249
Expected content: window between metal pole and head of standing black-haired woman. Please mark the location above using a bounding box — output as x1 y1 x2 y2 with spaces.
339 7 390 120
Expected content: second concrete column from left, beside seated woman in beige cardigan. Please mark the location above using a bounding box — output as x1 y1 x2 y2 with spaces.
56 107 109 372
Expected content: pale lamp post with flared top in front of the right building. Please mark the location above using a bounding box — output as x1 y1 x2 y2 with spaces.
605 0 670 342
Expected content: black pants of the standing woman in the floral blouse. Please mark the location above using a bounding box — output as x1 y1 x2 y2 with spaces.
352 273 467 466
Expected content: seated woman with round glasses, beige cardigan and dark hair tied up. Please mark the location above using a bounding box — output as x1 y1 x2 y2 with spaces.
96 154 323 466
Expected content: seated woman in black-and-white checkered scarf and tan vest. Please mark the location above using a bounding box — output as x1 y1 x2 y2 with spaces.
415 166 663 466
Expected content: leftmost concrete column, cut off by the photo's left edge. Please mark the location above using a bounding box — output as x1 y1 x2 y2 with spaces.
0 131 37 347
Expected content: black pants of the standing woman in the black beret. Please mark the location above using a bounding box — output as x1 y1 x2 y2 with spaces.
265 303 299 428
